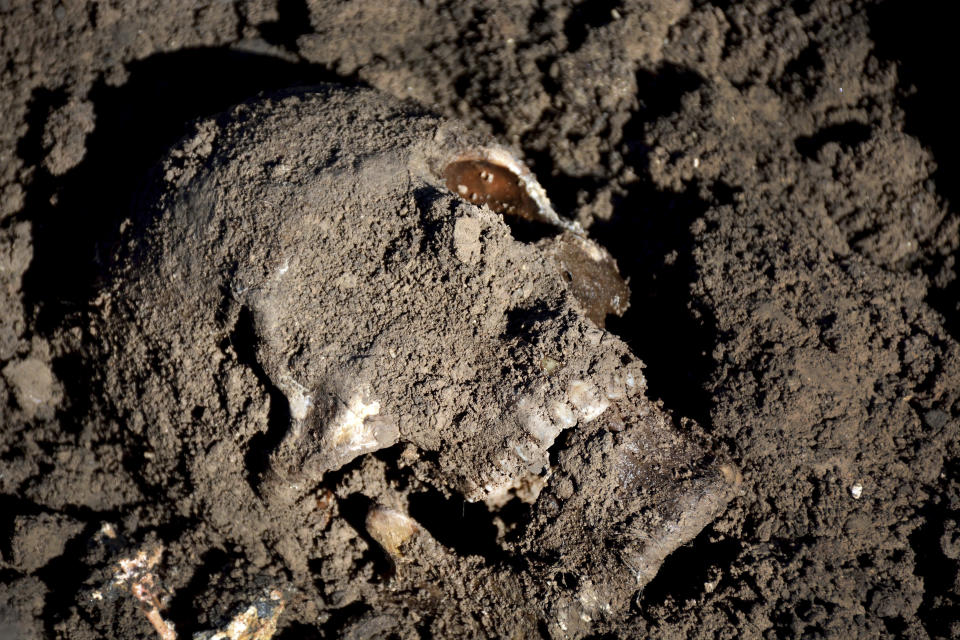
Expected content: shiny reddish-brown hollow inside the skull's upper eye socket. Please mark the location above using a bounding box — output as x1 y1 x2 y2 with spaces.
443 160 544 222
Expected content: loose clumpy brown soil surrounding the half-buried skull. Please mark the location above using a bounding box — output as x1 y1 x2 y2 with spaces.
0 0 960 638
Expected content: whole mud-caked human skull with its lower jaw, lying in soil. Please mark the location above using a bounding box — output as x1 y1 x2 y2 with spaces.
101 87 735 635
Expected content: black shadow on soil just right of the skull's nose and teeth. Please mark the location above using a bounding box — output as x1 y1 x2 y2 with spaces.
534 65 729 429
